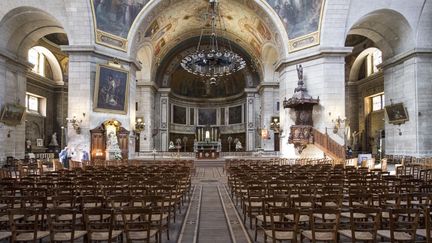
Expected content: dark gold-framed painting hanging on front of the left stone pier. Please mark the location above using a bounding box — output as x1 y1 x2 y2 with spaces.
93 65 129 114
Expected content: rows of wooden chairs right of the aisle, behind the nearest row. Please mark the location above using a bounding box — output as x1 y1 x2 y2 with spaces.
227 162 432 242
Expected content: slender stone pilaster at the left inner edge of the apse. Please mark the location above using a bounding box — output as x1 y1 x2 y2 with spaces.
159 88 171 151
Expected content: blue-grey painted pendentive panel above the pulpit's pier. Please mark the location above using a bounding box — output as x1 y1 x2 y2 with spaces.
267 0 324 51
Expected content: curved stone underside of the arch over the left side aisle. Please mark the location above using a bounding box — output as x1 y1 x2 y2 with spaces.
0 6 67 61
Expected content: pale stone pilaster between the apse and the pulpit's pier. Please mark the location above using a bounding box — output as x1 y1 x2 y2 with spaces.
259 82 279 151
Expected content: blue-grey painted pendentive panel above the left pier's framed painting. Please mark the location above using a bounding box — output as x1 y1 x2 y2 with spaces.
91 0 150 50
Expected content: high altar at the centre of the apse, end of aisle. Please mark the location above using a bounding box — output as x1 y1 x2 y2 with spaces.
194 126 222 159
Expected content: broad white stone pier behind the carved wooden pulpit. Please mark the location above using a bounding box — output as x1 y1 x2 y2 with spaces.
277 47 351 158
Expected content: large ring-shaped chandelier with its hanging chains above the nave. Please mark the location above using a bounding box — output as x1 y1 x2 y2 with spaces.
181 0 246 81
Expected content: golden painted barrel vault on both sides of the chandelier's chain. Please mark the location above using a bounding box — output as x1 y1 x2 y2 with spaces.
132 0 278 60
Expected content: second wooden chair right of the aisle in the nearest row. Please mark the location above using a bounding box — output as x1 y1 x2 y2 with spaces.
301 208 340 243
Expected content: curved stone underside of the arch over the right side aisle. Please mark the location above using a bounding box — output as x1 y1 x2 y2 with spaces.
347 9 414 59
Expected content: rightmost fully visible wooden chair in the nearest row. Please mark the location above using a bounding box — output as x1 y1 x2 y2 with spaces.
389 208 420 242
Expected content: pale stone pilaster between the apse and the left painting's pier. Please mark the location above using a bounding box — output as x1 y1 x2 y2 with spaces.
136 80 157 151
